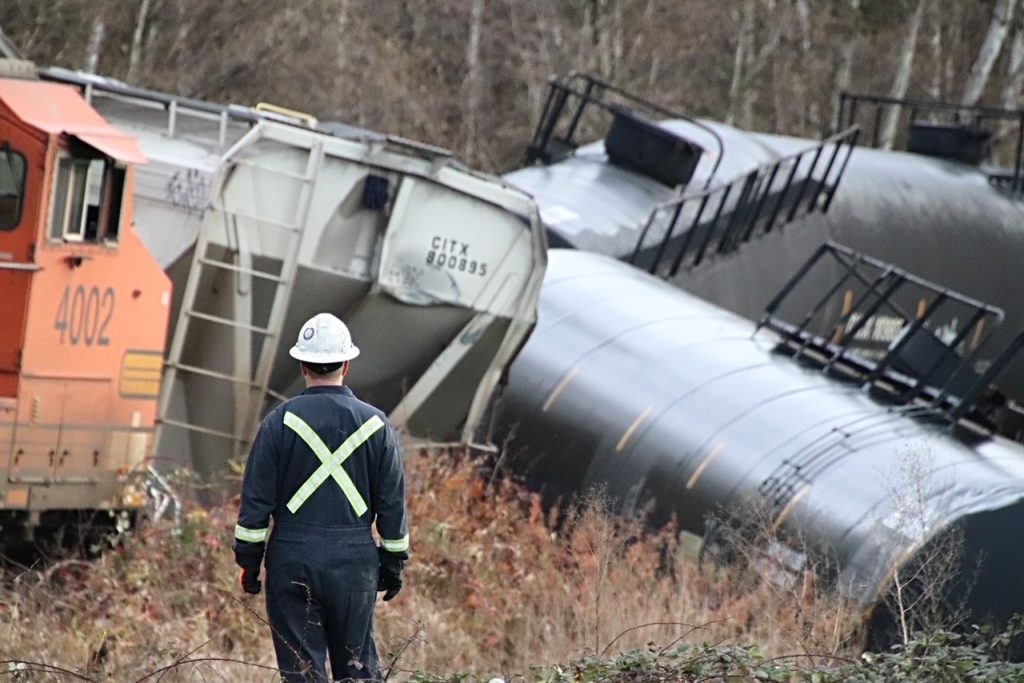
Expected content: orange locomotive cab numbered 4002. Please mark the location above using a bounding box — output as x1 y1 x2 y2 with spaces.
0 79 171 537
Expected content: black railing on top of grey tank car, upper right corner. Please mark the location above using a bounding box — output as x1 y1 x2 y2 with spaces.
836 91 1024 194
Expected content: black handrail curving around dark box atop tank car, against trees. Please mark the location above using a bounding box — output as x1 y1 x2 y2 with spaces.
524 72 725 187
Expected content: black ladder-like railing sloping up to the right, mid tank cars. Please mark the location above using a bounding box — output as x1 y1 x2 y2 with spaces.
630 126 859 278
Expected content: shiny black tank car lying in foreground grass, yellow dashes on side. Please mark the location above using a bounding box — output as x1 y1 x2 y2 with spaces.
500 250 1024 638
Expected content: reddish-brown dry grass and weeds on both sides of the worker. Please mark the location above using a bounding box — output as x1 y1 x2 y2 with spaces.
0 454 853 681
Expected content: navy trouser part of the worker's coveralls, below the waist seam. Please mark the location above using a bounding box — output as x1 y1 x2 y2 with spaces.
266 523 379 682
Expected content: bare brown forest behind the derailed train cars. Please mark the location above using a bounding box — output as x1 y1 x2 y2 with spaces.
6 0 1024 172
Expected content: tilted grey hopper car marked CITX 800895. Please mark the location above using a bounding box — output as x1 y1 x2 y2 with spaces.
41 69 547 480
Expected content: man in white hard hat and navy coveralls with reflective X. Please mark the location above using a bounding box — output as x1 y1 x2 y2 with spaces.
234 313 409 681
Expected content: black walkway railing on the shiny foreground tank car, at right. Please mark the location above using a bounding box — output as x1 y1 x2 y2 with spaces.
758 243 1024 431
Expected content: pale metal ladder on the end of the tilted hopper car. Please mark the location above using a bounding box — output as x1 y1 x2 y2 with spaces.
158 126 324 464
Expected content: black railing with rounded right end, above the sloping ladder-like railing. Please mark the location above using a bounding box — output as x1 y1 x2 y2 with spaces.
525 73 724 186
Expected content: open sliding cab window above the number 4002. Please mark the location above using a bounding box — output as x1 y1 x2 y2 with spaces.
50 150 125 243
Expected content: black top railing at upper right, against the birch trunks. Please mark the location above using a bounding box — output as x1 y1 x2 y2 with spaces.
837 92 1024 194
